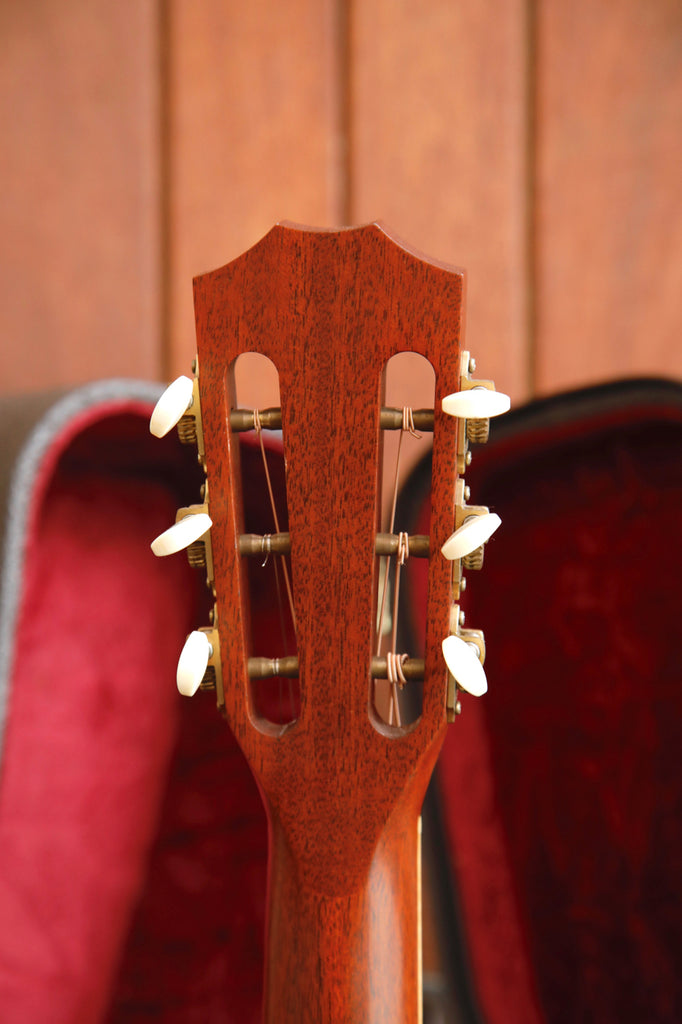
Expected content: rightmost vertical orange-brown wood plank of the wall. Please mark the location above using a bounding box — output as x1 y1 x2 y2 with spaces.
537 0 682 391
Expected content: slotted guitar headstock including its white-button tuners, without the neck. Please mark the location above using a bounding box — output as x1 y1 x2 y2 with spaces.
153 224 508 870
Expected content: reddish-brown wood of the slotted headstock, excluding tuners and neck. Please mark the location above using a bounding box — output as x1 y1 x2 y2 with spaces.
195 224 464 813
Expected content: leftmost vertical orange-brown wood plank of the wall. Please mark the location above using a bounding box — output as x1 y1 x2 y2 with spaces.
0 0 160 391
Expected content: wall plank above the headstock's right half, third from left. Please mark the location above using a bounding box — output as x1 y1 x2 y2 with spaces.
349 0 528 415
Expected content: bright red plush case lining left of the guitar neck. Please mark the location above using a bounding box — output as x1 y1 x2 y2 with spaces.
0 406 281 1024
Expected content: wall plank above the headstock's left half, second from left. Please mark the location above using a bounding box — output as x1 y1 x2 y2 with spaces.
168 0 342 404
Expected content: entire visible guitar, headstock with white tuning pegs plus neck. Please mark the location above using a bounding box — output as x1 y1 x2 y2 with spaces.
151 224 509 1024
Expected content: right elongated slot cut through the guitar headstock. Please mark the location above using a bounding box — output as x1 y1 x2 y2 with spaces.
371 351 435 732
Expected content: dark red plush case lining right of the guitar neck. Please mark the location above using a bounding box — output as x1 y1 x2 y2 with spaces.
401 395 682 1024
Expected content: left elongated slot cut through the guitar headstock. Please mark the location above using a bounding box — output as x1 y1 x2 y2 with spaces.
227 351 300 726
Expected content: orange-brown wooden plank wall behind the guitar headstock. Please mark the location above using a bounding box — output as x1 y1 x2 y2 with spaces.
0 0 682 401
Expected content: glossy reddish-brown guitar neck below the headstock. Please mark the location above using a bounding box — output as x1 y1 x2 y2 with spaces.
264 778 422 1024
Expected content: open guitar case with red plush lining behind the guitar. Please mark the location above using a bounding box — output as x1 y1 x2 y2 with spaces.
0 381 682 1024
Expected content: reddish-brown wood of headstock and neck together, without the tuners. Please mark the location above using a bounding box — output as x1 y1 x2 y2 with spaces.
195 225 463 1024
